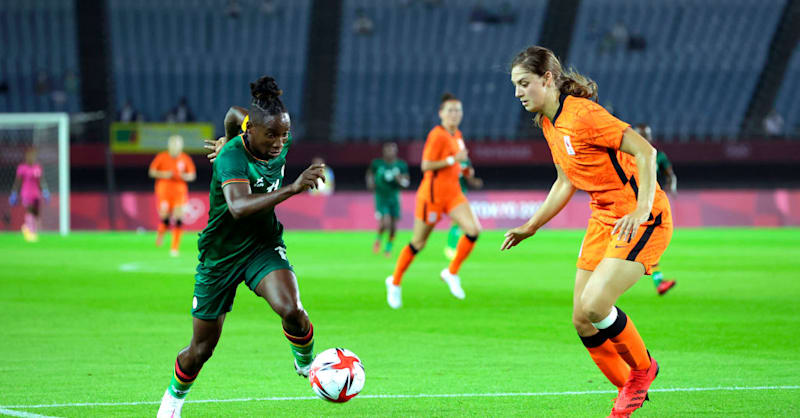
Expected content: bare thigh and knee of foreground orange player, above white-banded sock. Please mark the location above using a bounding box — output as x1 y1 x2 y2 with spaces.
580 258 644 322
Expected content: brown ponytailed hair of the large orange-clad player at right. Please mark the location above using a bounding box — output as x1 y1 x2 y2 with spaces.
511 45 597 126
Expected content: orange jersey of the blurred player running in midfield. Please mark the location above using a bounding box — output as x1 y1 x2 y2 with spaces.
417 125 465 202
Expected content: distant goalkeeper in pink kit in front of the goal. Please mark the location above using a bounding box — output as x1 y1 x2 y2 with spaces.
8 148 50 242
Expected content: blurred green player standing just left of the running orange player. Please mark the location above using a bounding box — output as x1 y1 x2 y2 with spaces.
366 142 410 257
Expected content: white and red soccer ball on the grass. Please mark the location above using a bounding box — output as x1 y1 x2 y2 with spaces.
308 348 366 402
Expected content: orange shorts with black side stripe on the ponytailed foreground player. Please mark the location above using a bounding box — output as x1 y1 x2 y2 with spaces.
577 210 672 274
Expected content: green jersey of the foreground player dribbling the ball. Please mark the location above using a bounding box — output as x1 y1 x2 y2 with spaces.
197 135 292 275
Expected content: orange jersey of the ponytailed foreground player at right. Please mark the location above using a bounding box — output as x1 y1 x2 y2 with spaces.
541 96 669 225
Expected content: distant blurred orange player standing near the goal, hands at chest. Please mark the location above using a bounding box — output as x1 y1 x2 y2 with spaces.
148 135 197 257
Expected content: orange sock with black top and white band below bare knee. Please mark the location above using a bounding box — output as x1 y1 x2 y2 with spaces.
594 306 650 370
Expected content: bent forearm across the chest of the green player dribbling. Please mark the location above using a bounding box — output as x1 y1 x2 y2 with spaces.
222 164 325 219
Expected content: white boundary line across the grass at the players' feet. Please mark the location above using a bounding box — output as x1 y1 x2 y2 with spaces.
0 385 800 410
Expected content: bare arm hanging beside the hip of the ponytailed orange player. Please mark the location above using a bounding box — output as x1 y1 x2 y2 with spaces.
611 127 656 241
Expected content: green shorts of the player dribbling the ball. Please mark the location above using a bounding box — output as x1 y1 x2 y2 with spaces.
192 244 294 320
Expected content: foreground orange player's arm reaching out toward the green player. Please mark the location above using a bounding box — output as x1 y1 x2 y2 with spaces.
500 164 575 251
